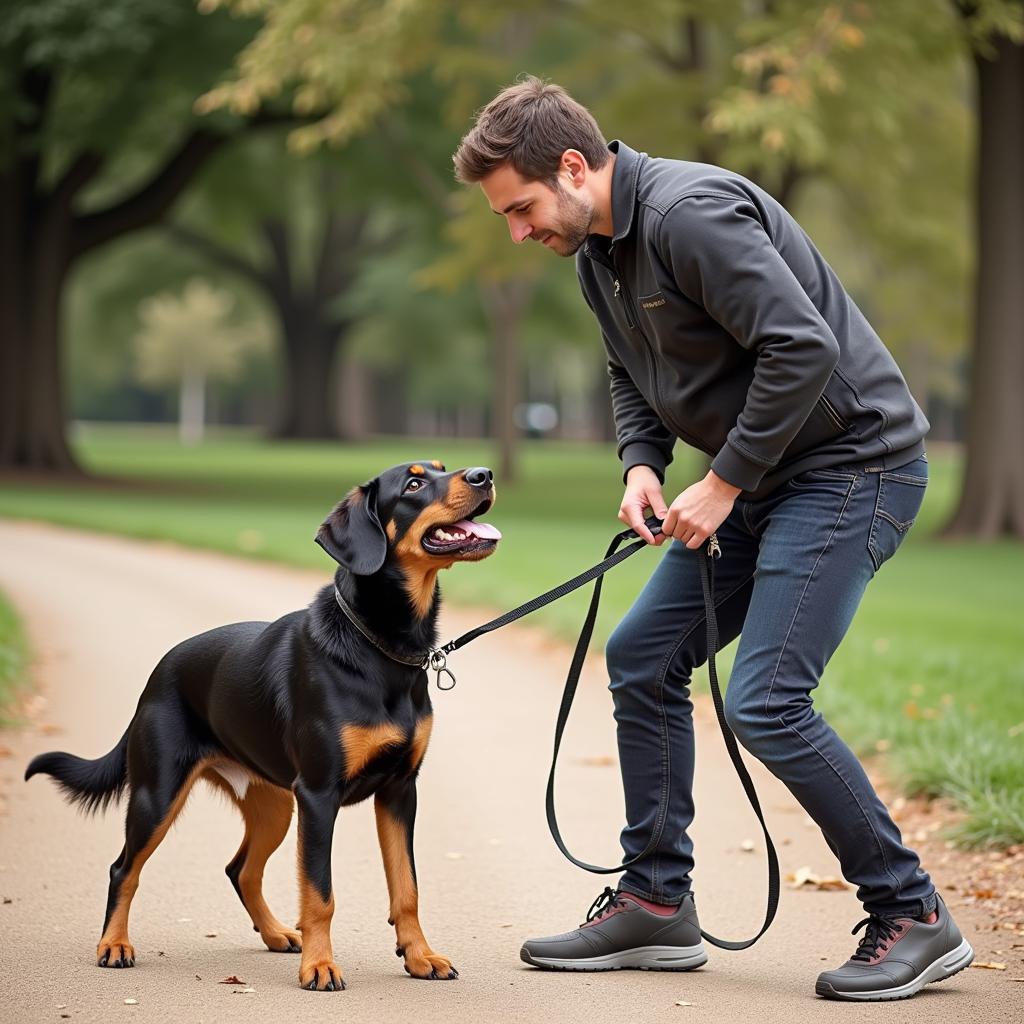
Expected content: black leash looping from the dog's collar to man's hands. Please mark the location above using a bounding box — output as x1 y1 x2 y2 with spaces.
423 516 779 949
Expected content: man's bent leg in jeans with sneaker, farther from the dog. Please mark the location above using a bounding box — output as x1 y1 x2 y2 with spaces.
726 460 974 1000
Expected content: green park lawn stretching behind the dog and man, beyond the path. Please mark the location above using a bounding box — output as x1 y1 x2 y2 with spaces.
0 426 1024 846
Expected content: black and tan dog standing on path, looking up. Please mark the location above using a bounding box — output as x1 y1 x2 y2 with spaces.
26 462 501 991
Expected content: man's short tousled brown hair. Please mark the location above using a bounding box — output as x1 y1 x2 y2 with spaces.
452 75 609 186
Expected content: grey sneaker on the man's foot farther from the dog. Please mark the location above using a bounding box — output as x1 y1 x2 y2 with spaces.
814 896 974 1000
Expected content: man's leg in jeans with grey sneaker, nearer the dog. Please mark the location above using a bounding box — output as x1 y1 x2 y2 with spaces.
520 511 757 971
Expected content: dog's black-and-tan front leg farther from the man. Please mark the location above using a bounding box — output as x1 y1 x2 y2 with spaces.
293 778 345 992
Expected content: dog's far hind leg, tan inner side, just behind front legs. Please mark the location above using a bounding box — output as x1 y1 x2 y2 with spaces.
214 771 302 953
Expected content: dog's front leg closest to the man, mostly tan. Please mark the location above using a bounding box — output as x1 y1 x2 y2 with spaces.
374 778 459 980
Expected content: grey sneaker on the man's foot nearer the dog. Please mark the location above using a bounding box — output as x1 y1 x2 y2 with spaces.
519 889 708 971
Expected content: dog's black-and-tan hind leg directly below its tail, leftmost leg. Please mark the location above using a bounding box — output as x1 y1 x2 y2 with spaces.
96 735 203 967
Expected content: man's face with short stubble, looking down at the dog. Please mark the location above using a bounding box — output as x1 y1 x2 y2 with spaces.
480 164 594 256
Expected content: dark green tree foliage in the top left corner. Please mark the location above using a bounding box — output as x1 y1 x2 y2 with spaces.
0 0 253 177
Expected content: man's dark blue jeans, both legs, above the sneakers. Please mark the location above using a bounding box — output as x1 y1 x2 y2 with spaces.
605 456 936 915
